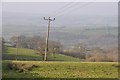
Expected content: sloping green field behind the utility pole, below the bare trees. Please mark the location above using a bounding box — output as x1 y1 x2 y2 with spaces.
3 47 80 61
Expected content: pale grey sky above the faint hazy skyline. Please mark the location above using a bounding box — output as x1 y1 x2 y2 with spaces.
2 2 118 16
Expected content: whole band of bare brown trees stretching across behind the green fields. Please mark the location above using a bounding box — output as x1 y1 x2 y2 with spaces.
0 35 118 62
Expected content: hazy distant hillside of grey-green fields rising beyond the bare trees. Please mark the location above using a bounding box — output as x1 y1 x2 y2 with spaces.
3 25 118 47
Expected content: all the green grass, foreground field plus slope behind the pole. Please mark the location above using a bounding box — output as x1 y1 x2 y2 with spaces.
2 47 119 80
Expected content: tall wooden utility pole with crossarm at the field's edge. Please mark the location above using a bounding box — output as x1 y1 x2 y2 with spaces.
44 17 55 61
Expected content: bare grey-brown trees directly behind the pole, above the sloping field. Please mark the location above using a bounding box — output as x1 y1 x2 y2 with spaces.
10 35 62 54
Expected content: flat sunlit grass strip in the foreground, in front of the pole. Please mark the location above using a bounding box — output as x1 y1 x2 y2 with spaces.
3 61 118 78
